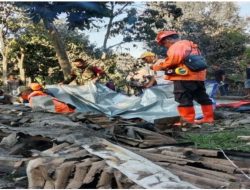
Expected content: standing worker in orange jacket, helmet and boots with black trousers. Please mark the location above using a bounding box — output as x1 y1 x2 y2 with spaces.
152 31 214 124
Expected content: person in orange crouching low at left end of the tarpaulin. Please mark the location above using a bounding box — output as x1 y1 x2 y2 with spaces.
18 83 75 113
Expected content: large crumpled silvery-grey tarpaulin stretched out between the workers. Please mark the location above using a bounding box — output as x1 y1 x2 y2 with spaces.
47 82 215 122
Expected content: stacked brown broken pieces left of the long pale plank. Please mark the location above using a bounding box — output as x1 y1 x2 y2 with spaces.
26 143 140 189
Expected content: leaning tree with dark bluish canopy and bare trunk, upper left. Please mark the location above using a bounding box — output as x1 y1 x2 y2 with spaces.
16 2 109 78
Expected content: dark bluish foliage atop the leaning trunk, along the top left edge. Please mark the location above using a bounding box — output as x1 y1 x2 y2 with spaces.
16 2 110 29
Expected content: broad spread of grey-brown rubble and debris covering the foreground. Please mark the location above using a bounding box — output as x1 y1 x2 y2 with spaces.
0 105 250 188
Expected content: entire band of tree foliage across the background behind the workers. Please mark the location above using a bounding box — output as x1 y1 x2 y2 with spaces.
0 1 250 94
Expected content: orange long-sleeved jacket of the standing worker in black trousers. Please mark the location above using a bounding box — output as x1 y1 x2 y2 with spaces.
153 40 206 81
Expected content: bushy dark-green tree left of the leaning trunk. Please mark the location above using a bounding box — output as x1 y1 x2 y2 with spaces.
10 23 59 81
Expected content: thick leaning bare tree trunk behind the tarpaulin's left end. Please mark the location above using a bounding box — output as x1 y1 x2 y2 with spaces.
43 20 71 79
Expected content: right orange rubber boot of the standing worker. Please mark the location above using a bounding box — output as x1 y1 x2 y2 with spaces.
195 105 214 124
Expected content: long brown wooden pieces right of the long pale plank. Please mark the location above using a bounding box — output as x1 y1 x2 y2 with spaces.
134 146 250 188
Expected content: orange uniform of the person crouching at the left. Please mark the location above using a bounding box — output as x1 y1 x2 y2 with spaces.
28 91 75 113
